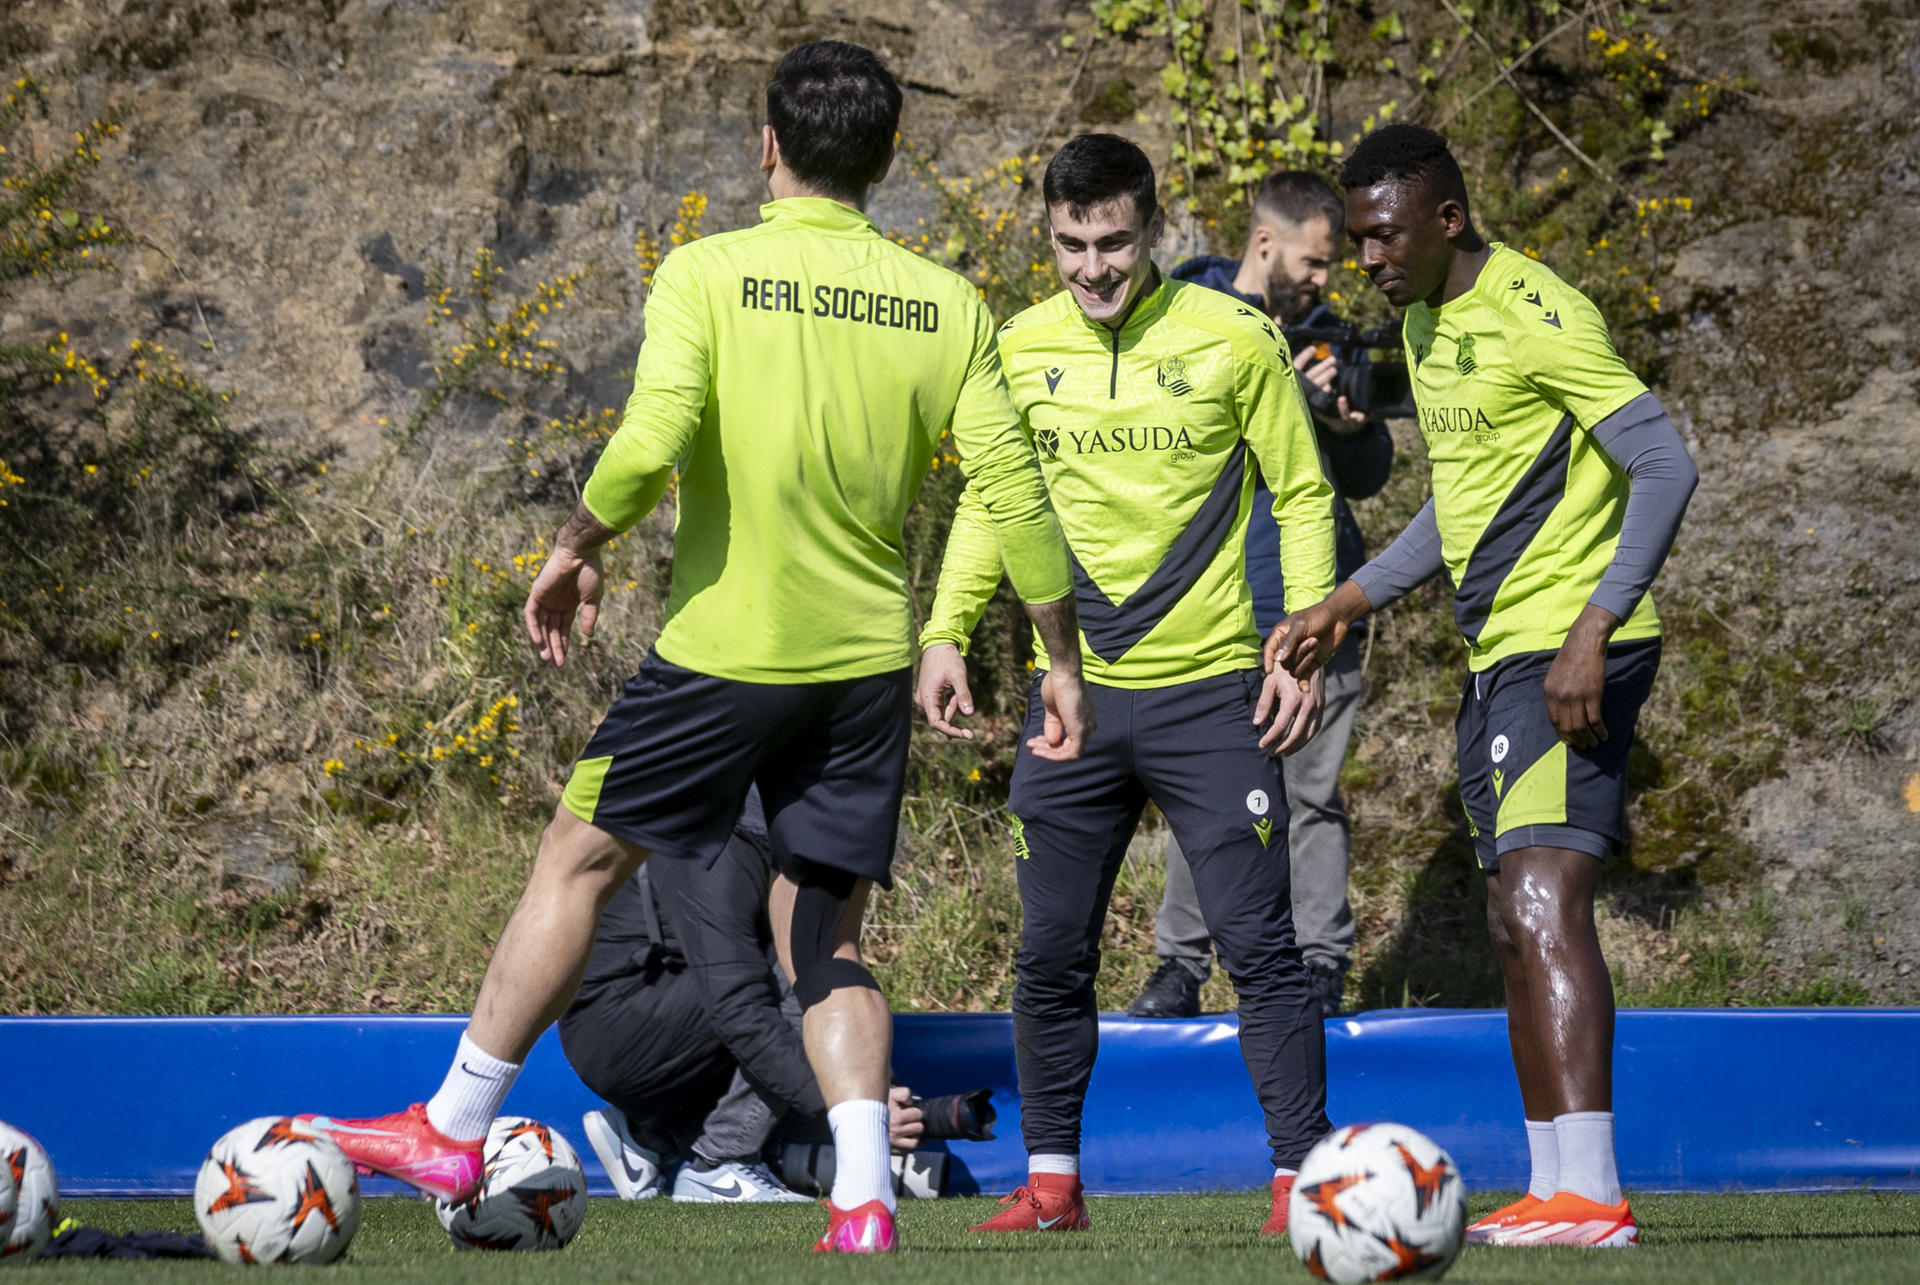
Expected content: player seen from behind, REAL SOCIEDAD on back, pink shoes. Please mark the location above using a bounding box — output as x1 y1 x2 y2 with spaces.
295 40 1091 1252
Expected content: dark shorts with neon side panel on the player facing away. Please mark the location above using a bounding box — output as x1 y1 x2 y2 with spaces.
563 655 914 887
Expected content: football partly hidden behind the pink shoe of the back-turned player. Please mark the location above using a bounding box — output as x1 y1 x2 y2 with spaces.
440 1116 588 1250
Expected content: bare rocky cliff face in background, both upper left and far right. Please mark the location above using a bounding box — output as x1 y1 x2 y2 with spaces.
0 0 1920 997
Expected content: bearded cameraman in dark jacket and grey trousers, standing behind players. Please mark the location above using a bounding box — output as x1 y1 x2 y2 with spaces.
1129 169 1394 1018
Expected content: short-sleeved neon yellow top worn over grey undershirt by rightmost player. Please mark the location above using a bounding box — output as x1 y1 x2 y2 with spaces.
1404 242 1661 670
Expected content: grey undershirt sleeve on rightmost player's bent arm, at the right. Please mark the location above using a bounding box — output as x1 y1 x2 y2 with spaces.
1588 392 1699 620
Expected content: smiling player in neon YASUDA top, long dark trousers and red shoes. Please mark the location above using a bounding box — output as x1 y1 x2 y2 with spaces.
920 134 1334 1231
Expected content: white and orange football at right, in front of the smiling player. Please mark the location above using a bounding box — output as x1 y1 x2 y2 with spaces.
1286 1124 1467 1283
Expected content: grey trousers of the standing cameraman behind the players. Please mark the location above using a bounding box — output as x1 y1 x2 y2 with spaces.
1154 636 1359 970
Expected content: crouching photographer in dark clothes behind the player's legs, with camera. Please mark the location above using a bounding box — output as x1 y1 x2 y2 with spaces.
559 791 993 1202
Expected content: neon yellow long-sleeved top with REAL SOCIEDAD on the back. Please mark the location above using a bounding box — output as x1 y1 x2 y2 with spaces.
584 198 1071 682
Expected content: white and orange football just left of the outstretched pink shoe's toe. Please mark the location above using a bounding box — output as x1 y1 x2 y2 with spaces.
194 1116 359 1264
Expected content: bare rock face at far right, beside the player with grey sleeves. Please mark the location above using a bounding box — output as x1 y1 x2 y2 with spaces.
1663 2 1920 995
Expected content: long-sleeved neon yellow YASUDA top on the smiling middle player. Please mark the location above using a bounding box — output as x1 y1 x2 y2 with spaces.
920 279 1332 688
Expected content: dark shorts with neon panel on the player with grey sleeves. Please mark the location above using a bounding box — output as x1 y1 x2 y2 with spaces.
1453 638 1661 870
